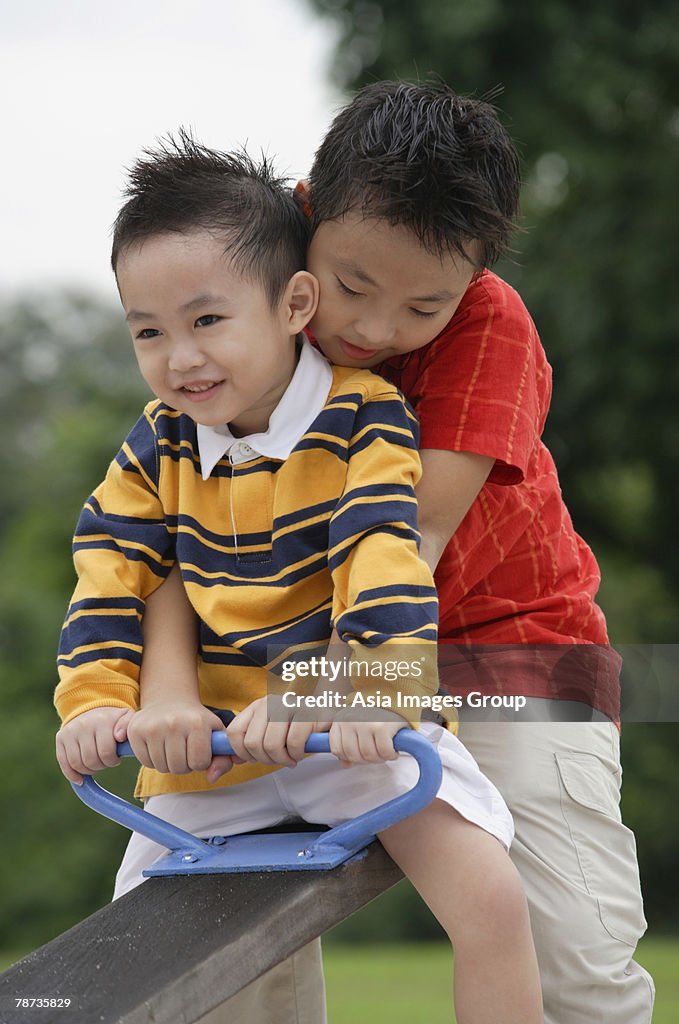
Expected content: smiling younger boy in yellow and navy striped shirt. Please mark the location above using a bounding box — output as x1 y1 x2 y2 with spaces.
55 136 542 1024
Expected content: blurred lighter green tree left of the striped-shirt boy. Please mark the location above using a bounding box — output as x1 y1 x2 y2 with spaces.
0 294 148 949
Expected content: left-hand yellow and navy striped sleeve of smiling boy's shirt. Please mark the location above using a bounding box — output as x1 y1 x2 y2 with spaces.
54 402 174 722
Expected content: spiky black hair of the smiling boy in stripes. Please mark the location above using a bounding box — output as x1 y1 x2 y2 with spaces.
111 129 309 307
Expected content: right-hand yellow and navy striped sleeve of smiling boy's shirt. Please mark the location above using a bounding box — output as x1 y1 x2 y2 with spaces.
329 390 437 693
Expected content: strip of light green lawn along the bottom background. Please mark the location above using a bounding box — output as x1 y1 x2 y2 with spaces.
0 937 679 1024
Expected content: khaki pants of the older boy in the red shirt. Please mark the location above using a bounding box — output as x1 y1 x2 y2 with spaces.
214 721 654 1024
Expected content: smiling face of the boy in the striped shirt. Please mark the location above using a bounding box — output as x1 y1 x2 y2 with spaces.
116 230 296 435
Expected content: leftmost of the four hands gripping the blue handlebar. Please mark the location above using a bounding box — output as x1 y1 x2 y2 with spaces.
56 708 134 785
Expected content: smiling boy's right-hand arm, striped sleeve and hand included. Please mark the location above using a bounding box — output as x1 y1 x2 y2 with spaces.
329 393 438 766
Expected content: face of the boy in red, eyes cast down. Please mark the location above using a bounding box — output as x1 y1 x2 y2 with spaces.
307 213 477 367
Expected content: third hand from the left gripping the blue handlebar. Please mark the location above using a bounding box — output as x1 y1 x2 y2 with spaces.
226 696 330 768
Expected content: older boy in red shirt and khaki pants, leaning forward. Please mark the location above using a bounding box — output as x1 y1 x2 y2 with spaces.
134 82 653 1024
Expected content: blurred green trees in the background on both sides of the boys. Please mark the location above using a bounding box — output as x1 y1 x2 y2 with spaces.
0 0 679 949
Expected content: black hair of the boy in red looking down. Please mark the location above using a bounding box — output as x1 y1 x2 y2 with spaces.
309 82 520 267
